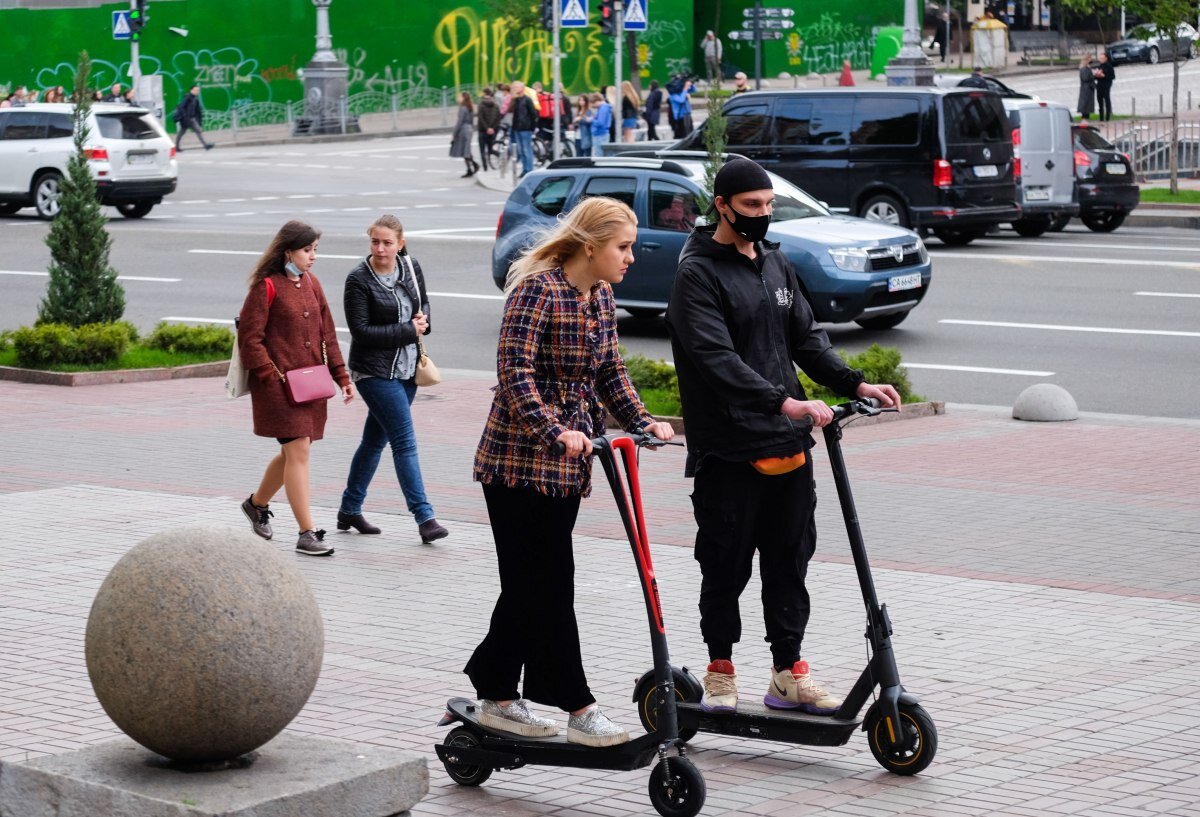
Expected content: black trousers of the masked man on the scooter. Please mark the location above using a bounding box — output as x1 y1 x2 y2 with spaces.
691 456 817 667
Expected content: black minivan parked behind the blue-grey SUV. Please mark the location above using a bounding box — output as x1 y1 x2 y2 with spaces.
671 88 1021 245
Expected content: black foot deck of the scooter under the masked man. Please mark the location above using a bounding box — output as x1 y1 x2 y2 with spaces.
676 701 863 746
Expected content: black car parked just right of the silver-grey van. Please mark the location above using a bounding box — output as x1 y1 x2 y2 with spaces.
1051 122 1141 233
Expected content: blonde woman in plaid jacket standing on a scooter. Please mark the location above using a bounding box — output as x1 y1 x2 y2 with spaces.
464 197 673 746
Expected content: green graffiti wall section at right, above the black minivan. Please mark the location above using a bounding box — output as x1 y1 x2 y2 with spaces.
694 0 904 78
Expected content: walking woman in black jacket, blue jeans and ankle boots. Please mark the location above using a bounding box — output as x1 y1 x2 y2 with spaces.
337 215 450 545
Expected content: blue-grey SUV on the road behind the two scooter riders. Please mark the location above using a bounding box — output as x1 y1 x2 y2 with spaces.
492 151 931 329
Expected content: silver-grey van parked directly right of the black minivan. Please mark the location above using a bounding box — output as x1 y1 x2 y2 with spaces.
1004 100 1079 238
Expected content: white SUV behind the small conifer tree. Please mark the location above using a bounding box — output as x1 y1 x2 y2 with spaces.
0 102 179 218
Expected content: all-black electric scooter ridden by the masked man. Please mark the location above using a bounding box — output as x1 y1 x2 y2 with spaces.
634 400 937 775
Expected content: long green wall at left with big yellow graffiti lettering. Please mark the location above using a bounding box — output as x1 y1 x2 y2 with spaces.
0 0 695 110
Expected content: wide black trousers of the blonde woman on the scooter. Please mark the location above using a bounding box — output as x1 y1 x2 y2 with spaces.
463 485 595 711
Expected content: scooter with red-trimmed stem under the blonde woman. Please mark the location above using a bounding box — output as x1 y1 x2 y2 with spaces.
434 434 706 817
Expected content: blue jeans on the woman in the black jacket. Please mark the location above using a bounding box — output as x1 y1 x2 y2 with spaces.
341 377 434 524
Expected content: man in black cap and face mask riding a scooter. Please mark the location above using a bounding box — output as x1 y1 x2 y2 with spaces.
667 158 900 715
